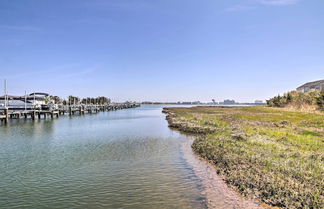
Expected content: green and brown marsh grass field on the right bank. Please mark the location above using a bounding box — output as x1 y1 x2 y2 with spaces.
164 106 324 208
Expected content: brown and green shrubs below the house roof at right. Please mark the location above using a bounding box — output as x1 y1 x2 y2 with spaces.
267 91 324 110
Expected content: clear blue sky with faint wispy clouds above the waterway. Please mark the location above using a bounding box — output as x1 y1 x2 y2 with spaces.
0 0 324 102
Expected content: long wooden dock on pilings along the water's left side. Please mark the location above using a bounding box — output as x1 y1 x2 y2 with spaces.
0 103 140 124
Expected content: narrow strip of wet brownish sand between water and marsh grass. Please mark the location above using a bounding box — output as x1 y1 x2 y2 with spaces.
181 140 263 209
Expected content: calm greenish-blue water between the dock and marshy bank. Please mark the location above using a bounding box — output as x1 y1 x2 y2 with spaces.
0 106 205 209
